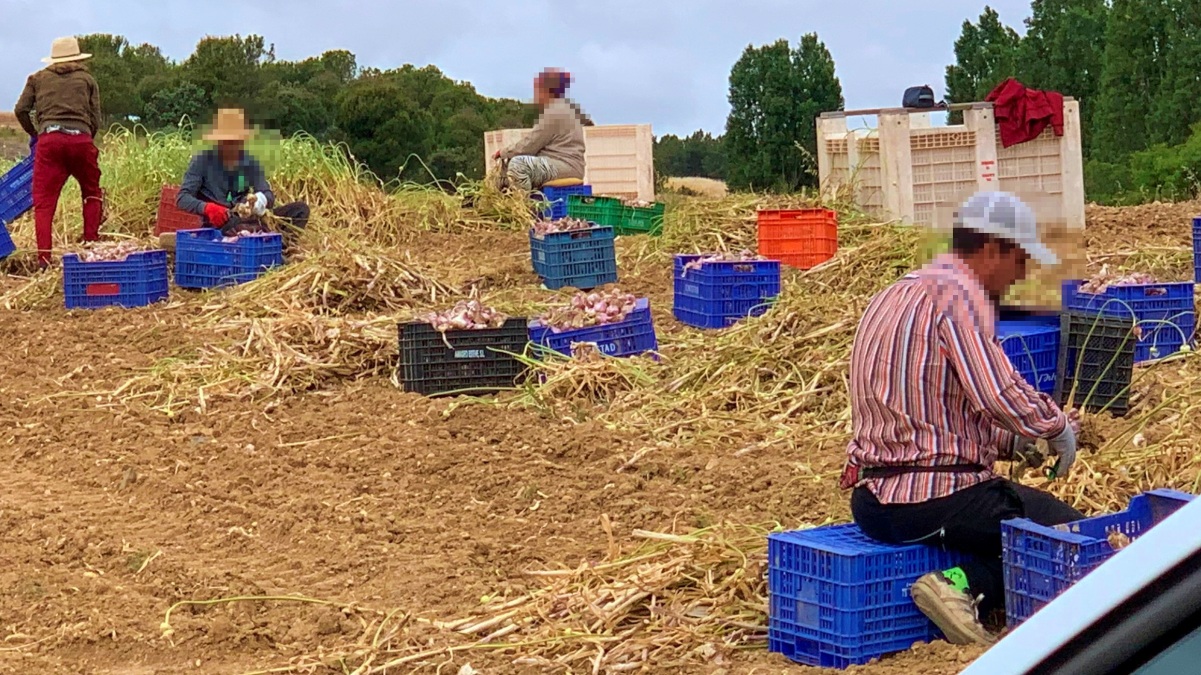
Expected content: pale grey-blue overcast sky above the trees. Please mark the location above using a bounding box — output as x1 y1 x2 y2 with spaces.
0 0 1029 135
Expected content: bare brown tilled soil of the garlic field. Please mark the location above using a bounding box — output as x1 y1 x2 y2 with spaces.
0 190 1199 675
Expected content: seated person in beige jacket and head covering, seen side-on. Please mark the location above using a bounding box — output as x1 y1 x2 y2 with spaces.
492 68 592 192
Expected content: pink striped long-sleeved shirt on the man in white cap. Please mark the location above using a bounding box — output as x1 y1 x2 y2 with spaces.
841 253 1068 503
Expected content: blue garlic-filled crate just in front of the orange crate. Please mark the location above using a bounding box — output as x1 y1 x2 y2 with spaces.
671 256 779 328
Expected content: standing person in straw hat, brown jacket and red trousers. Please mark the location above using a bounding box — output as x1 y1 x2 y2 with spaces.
13 37 103 268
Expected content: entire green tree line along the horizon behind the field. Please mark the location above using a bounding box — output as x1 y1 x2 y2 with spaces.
68 7 1201 202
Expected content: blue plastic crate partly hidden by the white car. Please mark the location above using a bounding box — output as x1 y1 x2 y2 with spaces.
1000 490 1193 628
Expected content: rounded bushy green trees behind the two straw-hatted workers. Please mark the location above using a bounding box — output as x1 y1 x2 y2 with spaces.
66 35 537 181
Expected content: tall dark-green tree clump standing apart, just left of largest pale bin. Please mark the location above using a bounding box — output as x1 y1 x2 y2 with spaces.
724 34 843 190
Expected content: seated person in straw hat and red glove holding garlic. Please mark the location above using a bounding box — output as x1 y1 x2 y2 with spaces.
175 109 309 247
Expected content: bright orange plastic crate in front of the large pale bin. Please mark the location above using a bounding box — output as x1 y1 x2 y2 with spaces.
759 209 838 269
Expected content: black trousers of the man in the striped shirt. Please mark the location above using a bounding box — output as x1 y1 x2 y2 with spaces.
850 478 1085 616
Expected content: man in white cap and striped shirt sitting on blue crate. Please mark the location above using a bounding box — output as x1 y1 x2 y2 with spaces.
842 192 1083 644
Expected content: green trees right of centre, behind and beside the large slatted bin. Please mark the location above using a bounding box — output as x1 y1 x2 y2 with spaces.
672 0 1201 203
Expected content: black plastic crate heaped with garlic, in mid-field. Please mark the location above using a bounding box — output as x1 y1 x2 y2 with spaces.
399 318 530 396
